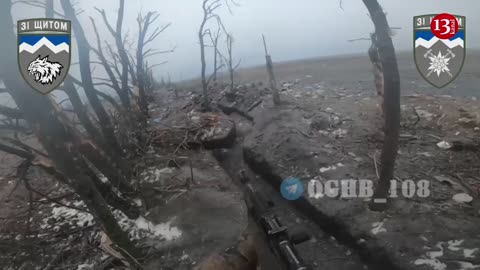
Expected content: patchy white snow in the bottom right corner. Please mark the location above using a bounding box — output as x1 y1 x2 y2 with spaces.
414 239 480 270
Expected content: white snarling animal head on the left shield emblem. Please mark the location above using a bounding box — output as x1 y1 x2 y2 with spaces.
28 56 63 84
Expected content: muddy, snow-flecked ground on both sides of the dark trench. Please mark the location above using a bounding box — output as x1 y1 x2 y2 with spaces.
0 52 480 270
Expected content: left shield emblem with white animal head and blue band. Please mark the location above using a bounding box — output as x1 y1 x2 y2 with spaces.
17 19 71 94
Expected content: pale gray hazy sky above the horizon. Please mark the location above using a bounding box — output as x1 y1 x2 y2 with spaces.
11 0 480 80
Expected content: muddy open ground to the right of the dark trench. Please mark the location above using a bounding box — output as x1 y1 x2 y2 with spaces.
174 49 480 269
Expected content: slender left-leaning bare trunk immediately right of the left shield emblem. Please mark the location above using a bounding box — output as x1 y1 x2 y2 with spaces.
61 0 125 157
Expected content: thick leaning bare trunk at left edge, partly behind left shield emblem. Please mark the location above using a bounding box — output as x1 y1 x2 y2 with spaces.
0 1 139 256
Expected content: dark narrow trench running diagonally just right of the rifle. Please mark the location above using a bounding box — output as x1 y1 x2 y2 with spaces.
212 115 403 270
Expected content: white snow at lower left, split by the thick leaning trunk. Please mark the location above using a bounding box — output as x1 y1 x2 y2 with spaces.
41 201 182 241
